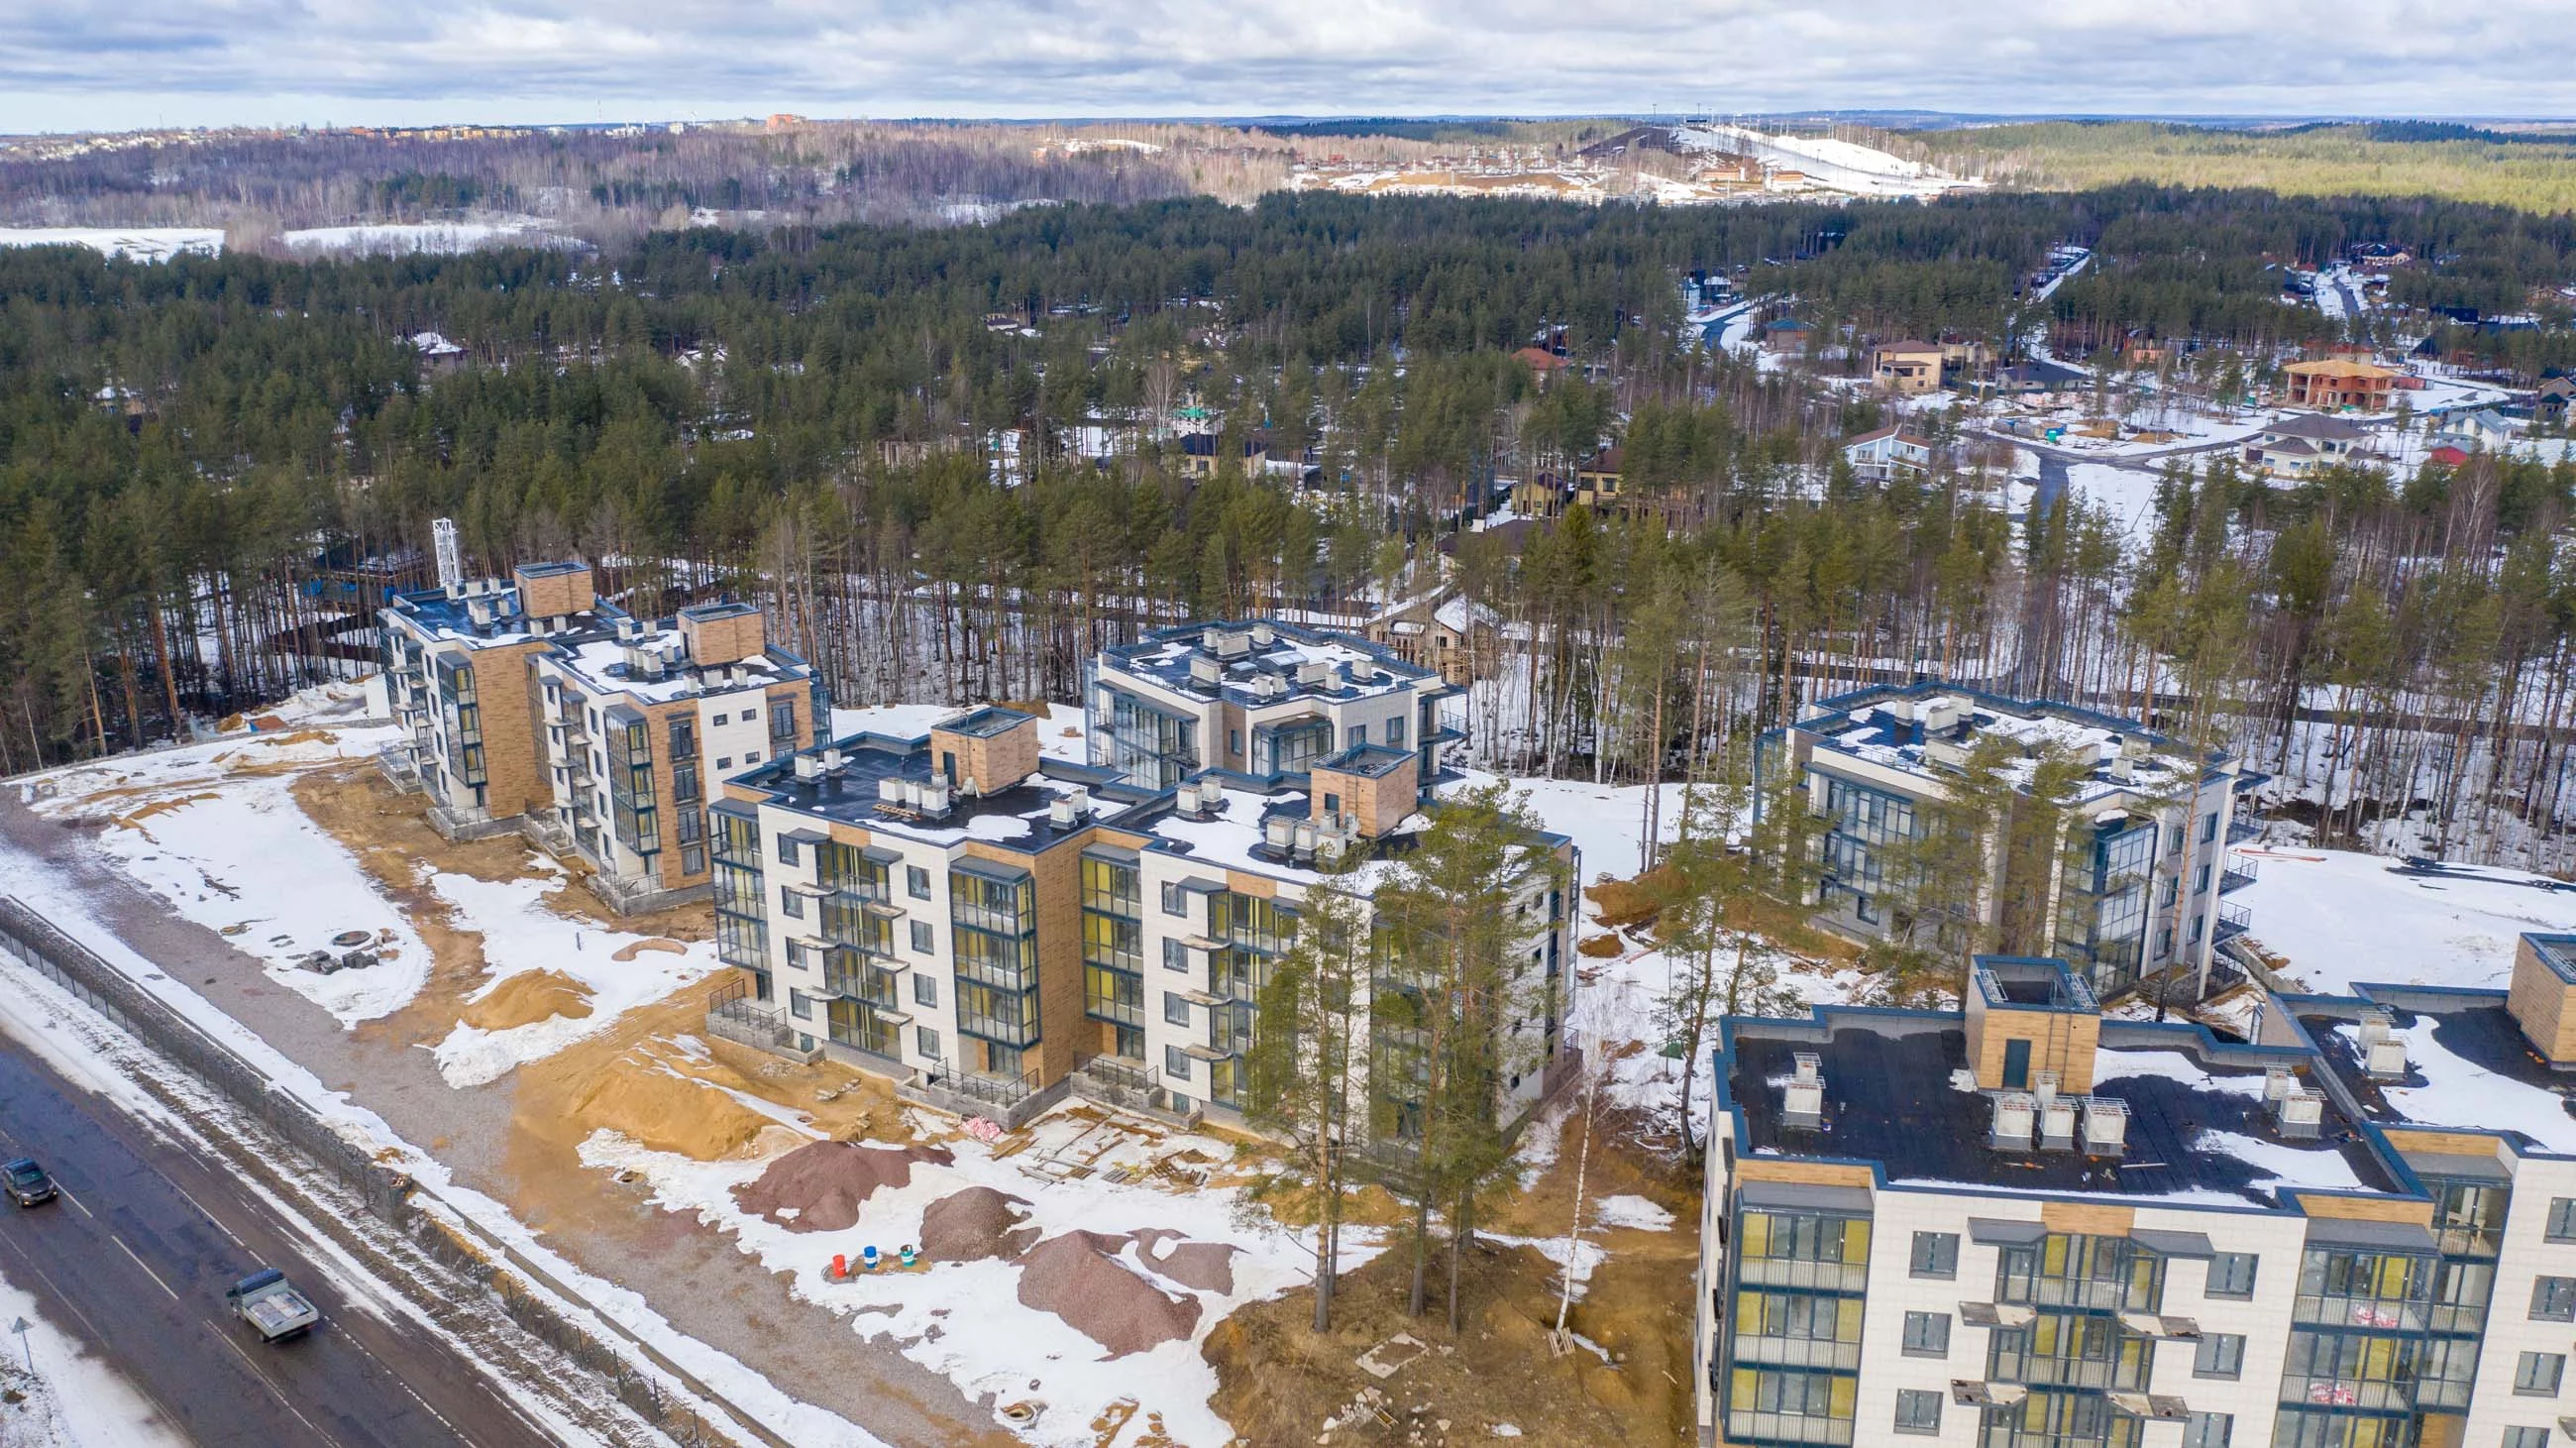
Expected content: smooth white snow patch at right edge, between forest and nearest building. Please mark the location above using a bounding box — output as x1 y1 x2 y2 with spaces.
2231 847 2576 992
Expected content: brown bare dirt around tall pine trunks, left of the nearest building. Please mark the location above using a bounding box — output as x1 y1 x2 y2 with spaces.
1206 1097 1700 1448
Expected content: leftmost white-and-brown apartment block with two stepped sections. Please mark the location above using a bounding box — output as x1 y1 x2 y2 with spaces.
381 562 829 910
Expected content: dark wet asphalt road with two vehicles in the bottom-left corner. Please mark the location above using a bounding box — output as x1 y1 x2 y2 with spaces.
0 1039 554 1448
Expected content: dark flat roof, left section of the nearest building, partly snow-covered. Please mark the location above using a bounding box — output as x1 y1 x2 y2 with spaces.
1718 1007 2404 1208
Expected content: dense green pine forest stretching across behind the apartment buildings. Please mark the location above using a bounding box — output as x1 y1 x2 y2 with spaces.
0 185 2576 871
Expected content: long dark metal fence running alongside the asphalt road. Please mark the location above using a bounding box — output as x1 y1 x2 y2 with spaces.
0 897 791 1448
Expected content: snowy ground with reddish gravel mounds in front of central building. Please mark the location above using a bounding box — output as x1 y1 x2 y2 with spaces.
583 1105 1378 1448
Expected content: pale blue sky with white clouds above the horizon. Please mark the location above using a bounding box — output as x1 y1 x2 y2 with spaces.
0 0 2576 132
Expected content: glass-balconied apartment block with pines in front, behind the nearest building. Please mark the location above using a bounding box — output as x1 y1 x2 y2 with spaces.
1757 683 2262 994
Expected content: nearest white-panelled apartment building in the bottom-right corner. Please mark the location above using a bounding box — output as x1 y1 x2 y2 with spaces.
1692 936 2576 1448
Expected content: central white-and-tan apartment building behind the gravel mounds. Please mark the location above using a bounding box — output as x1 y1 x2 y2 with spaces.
708 685 1576 1123
